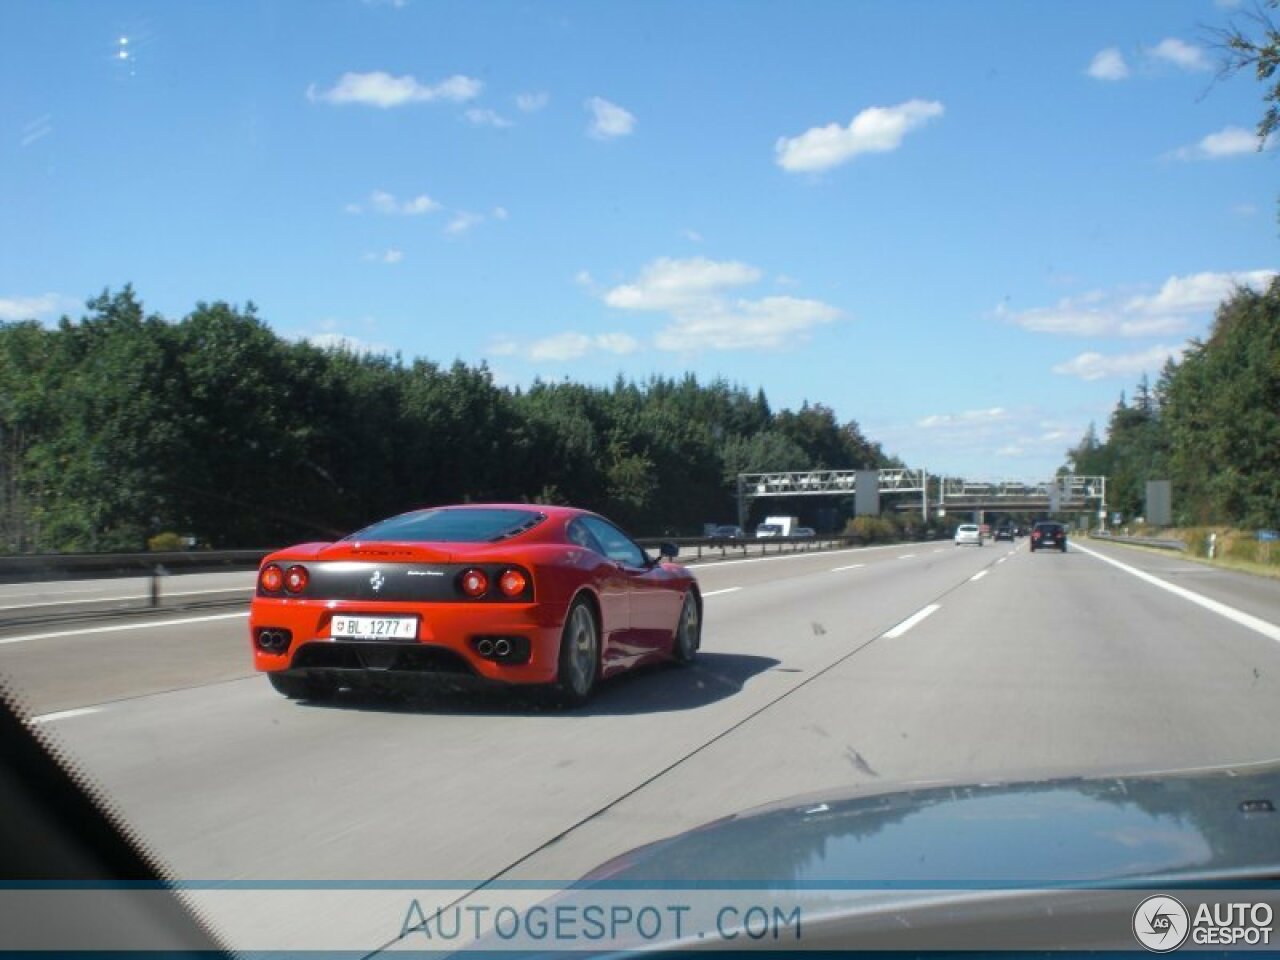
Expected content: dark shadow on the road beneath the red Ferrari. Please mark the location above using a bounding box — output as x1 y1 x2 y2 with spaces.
298 653 780 719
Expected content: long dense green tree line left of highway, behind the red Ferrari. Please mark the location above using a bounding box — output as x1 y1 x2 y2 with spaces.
0 287 896 553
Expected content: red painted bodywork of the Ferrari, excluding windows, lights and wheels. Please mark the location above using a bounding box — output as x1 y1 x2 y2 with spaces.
250 504 700 685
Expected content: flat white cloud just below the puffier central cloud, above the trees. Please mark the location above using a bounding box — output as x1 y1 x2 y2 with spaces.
655 297 841 353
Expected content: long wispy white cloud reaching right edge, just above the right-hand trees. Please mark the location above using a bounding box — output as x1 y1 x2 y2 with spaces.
997 270 1276 337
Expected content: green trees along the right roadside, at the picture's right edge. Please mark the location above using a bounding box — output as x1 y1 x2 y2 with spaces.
1065 278 1280 527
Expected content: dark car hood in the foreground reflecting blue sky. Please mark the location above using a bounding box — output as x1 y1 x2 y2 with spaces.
577 763 1280 890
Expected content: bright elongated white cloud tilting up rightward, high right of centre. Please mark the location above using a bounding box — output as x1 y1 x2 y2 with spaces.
773 100 943 173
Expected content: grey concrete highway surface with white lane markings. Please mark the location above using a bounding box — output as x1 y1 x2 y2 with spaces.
0 540 1280 952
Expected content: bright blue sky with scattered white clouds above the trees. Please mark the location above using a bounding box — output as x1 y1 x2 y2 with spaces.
0 0 1277 479
